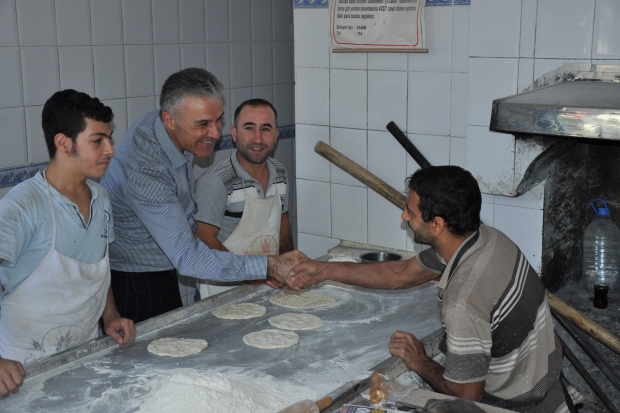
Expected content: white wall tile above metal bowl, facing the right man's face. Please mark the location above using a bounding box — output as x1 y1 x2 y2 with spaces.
368 190 407 250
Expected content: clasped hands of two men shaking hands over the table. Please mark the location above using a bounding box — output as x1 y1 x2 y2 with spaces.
266 250 323 291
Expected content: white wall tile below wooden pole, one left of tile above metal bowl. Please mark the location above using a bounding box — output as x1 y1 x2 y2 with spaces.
331 184 368 243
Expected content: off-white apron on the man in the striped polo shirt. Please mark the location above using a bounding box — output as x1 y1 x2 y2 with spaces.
198 182 282 299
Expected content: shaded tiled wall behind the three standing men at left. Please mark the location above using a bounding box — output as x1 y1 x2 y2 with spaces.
0 0 296 302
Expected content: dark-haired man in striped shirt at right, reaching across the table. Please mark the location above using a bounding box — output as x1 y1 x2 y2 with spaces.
294 166 581 413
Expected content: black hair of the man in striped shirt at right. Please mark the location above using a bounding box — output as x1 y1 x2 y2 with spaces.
407 166 482 236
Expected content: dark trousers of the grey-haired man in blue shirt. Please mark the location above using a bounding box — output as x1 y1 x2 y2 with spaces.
111 269 183 323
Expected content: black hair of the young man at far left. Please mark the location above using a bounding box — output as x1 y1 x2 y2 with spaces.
41 89 114 159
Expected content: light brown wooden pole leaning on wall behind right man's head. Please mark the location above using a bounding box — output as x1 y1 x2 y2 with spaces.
314 141 407 209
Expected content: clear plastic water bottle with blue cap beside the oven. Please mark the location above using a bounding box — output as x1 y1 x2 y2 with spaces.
583 198 620 308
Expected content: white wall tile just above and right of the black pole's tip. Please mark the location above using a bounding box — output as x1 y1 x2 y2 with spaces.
407 72 452 135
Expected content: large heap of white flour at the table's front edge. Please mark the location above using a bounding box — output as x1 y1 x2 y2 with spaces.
139 369 317 413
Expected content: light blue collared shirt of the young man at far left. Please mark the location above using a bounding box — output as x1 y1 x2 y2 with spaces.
0 172 114 302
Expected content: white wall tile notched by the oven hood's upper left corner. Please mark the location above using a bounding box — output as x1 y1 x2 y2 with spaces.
467 58 519 126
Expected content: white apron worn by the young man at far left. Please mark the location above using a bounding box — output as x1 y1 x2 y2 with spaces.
0 175 110 364
